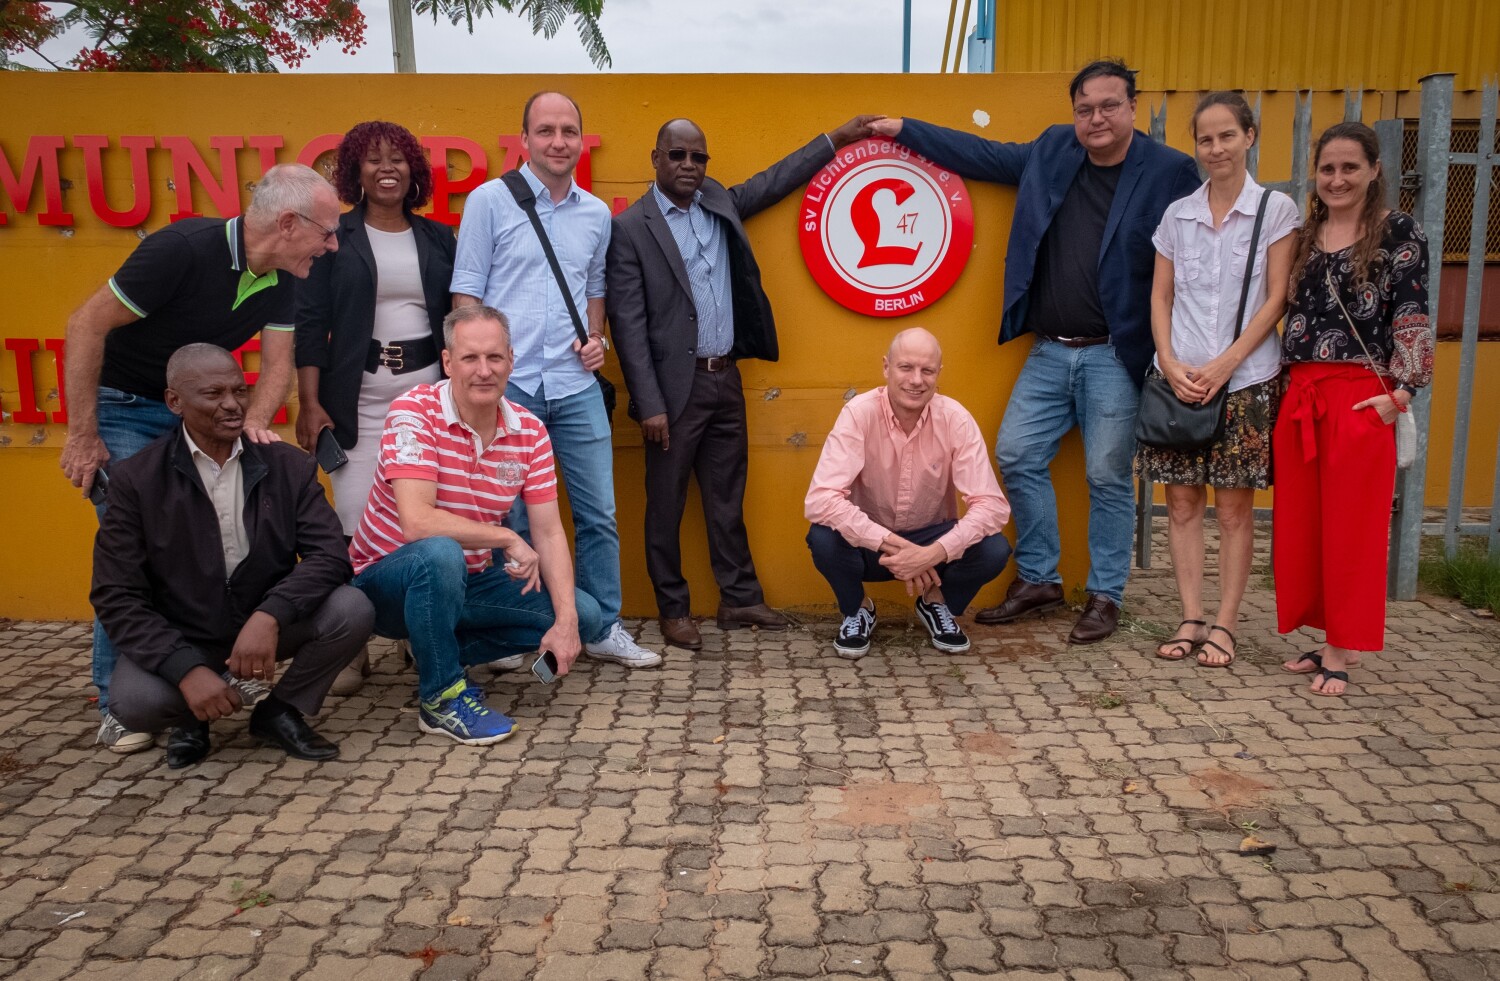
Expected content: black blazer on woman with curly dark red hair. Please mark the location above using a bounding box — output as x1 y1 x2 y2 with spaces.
296 203 458 450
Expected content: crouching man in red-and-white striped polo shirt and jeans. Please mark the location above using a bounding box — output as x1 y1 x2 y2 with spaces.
350 306 606 746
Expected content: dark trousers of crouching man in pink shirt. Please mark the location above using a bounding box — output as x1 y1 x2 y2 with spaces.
807 521 1011 617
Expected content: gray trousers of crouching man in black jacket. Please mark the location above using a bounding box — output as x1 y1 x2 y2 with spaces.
110 587 375 732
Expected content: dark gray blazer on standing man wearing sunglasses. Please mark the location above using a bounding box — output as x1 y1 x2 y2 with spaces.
605 135 834 422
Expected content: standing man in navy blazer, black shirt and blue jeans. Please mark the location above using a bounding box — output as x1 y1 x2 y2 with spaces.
872 62 1199 644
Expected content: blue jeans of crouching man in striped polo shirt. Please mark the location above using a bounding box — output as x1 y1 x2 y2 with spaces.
354 539 608 702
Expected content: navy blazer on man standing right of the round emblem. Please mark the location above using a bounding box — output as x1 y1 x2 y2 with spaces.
899 119 1202 384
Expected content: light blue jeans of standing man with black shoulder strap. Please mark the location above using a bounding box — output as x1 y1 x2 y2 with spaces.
506 384 621 627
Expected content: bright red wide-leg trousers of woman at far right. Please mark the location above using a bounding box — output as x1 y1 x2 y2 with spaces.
1271 363 1397 651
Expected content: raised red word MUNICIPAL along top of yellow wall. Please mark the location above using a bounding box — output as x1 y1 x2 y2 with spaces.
0 134 620 228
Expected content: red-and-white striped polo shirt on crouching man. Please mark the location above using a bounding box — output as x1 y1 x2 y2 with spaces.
350 381 558 573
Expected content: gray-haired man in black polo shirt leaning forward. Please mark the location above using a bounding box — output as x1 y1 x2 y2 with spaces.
60 164 339 753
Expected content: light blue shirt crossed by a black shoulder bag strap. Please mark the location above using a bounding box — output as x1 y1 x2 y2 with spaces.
452 164 609 399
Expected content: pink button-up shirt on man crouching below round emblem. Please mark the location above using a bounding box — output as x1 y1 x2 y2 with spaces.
804 386 1011 561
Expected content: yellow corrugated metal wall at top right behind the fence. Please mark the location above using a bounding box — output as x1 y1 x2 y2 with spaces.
995 0 1500 92
